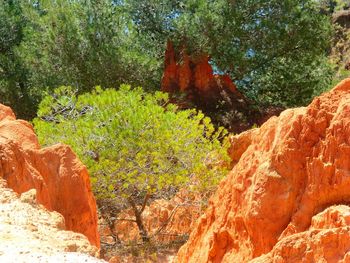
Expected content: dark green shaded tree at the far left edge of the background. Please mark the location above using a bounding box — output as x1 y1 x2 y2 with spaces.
0 0 35 117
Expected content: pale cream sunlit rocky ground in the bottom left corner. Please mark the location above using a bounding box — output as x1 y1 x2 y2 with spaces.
0 178 103 263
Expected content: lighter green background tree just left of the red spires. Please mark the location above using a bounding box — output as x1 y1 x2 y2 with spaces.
21 0 161 92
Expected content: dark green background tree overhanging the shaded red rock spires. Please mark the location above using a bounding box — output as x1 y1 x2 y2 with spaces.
125 0 333 107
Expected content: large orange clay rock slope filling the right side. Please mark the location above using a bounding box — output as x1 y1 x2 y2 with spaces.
177 79 350 262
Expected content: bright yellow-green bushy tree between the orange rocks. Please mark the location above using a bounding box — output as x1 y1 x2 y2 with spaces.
34 85 228 241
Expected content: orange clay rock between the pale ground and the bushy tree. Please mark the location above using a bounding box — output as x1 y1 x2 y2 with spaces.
0 104 100 247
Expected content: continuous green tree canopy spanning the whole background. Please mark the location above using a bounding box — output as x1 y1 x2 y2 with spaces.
0 0 336 119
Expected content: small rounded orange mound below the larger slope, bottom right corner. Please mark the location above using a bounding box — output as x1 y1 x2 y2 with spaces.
251 205 350 263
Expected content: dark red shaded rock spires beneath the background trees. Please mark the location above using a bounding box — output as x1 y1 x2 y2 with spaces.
161 41 270 132
